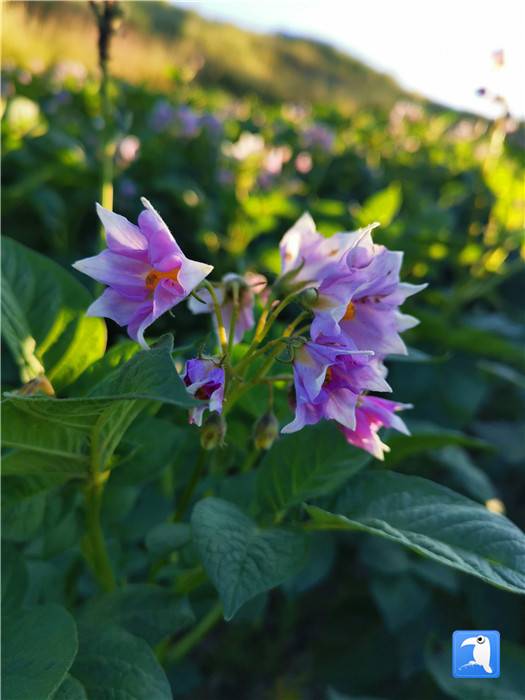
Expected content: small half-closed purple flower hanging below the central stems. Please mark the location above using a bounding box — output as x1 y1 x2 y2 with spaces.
182 359 224 426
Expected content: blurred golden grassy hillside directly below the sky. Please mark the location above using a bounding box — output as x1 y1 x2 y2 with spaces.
3 2 412 108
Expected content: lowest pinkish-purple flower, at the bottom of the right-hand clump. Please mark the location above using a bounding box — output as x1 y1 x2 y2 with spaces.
341 396 412 460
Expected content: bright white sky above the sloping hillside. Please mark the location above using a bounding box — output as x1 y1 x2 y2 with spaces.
174 0 525 118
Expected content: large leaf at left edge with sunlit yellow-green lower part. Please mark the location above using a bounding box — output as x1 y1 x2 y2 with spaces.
2 238 107 390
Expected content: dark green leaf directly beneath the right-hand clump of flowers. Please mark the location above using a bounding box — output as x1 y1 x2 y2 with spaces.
257 422 370 511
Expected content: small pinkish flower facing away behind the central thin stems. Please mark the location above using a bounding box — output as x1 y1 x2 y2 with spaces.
188 272 267 343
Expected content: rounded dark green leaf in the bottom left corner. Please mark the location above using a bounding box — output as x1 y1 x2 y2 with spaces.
2 605 78 700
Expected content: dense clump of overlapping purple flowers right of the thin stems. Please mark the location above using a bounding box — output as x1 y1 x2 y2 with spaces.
280 214 425 459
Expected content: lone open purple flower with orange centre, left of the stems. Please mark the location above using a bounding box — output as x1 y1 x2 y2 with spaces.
73 198 213 348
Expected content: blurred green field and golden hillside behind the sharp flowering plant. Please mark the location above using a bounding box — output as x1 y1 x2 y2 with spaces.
2 2 525 700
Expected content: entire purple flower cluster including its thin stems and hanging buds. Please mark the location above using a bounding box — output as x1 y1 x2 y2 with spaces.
75 199 425 459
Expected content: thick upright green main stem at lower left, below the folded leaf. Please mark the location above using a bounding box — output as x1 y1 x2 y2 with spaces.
85 474 117 591
